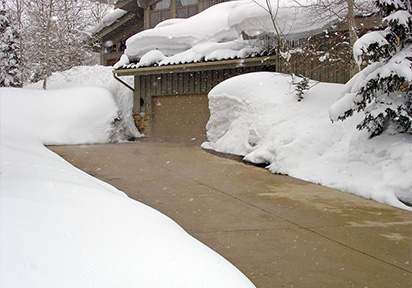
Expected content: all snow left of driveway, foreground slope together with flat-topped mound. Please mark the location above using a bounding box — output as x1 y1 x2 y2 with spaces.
0 87 254 288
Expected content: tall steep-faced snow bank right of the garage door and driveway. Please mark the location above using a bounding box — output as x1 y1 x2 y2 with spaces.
202 72 412 210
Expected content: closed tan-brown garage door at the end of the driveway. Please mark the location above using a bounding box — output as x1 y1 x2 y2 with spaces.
153 94 210 145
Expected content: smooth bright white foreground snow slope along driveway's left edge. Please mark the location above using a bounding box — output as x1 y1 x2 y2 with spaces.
0 129 254 288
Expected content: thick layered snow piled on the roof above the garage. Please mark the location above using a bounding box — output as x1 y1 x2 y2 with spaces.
115 0 337 68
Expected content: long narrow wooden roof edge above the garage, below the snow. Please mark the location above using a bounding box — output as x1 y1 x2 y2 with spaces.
113 56 276 76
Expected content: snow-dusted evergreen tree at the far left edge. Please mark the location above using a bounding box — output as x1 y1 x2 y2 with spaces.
0 1 21 87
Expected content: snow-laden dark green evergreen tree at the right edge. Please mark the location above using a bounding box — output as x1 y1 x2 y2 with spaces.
330 0 412 137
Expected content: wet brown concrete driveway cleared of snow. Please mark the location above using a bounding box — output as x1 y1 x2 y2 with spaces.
49 142 412 288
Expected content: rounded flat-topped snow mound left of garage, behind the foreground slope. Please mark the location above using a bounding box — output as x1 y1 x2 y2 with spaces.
0 87 118 145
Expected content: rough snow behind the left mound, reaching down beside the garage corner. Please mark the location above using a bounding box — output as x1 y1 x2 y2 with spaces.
25 65 142 144
